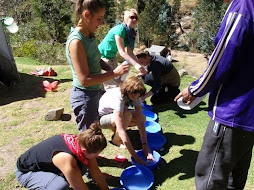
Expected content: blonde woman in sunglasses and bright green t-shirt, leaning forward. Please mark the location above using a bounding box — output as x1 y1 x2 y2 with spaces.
98 9 147 90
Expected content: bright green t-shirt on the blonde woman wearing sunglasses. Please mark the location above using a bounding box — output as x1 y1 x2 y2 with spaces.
99 24 129 59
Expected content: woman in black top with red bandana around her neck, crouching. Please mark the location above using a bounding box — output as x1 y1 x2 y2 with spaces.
16 123 109 190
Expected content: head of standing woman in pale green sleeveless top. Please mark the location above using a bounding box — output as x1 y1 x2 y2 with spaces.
75 0 105 29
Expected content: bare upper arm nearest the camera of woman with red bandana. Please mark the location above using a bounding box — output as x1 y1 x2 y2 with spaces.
52 152 88 190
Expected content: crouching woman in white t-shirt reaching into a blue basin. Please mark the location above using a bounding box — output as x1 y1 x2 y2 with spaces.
98 76 154 164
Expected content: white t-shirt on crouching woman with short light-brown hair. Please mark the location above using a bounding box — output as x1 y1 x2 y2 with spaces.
98 87 142 116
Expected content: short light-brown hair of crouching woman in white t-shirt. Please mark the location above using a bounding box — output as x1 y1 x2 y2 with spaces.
120 76 146 96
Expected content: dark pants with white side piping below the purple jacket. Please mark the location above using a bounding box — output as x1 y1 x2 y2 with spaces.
195 120 254 190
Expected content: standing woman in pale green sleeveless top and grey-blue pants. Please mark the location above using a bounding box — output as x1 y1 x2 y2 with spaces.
66 0 129 132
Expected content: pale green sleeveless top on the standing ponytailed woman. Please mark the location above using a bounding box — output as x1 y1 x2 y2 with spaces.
66 28 101 90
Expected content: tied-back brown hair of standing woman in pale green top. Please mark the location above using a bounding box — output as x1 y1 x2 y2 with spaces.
75 0 105 26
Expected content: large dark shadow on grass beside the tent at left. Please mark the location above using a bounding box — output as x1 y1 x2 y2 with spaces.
0 73 71 106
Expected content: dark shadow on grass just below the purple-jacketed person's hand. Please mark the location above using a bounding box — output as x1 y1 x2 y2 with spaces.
153 100 208 118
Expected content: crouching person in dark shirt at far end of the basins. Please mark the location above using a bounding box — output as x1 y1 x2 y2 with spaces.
136 50 180 104
